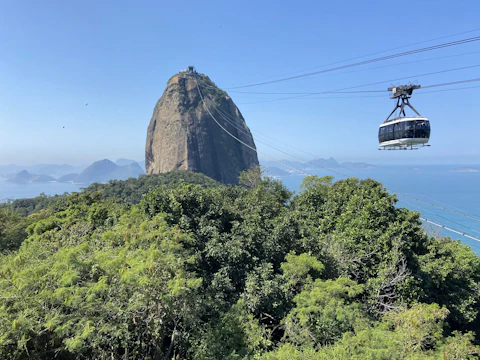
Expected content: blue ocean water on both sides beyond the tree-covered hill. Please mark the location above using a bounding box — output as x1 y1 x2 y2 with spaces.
0 165 480 253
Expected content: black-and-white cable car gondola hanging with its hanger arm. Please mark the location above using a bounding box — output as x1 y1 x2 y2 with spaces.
378 85 430 150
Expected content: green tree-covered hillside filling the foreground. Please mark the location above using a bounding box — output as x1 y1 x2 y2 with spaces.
0 171 480 360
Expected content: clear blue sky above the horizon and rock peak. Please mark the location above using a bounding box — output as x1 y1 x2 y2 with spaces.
0 0 480 164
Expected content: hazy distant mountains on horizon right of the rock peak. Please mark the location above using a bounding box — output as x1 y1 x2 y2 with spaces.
260 158 376 177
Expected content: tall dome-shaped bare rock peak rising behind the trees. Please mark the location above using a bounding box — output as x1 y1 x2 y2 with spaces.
145 73 258 184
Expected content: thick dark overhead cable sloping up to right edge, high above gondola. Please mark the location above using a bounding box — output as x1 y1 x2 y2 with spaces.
226 36 480 90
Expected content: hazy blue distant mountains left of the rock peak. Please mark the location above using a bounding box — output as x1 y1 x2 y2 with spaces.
0 159 145 184
